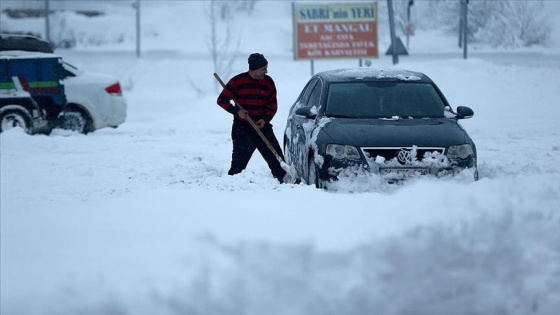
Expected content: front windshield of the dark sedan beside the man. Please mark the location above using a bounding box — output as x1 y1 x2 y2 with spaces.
325 81 445 118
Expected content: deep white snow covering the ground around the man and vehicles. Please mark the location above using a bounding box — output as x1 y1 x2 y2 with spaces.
0 1 560 315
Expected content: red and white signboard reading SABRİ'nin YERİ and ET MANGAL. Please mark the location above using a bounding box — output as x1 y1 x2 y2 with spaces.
293 2 379 59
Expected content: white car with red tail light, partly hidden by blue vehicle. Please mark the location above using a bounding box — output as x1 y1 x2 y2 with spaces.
0 50 127 133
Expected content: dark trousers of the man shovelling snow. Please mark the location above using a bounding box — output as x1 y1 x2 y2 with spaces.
228 120 286 182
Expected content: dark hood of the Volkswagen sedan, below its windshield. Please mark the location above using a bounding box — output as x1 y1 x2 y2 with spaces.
320 118 468 147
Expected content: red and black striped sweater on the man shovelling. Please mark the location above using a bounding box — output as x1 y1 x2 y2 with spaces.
217 72 278 122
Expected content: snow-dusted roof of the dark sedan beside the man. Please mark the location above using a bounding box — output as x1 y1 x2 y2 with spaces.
315 67 432 83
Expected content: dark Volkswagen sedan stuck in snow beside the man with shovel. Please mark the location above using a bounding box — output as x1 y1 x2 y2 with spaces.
284 68 478 187
